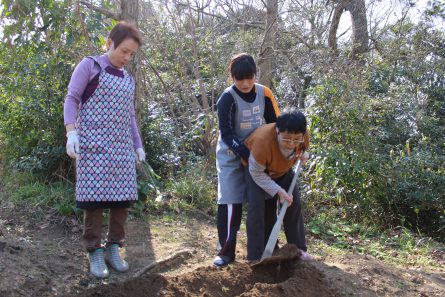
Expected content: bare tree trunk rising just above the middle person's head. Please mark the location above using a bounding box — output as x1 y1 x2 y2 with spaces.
258 0 278 87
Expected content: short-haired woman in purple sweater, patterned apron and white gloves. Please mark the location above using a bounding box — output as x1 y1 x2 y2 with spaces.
64 22 145 278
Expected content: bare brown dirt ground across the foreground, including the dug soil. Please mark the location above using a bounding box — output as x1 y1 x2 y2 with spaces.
0 201 445 297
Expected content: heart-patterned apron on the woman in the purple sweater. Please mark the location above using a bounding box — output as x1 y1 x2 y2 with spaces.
76 59 137 202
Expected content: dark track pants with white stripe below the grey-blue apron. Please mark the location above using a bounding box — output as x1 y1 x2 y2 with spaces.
217 203 243 260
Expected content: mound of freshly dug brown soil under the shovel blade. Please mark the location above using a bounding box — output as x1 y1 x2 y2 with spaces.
71 261 340 297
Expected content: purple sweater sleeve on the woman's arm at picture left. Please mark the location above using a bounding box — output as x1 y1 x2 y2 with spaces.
63 58 94 125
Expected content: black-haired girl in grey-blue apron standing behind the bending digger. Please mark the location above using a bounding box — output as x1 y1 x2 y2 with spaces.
213 53 279 267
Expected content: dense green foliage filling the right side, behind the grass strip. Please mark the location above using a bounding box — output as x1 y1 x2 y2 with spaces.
308 23 445 238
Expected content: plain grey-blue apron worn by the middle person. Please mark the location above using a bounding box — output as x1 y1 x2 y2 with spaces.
216 84 265 204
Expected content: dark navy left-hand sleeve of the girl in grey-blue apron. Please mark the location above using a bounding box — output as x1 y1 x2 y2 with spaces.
217 92 250 160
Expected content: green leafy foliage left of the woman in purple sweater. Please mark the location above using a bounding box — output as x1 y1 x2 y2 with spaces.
0 1 79 178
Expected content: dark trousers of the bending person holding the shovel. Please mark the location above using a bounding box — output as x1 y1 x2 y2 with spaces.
245 168 307 260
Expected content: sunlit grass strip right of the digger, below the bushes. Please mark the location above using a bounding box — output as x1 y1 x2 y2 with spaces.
306 213 445 269
